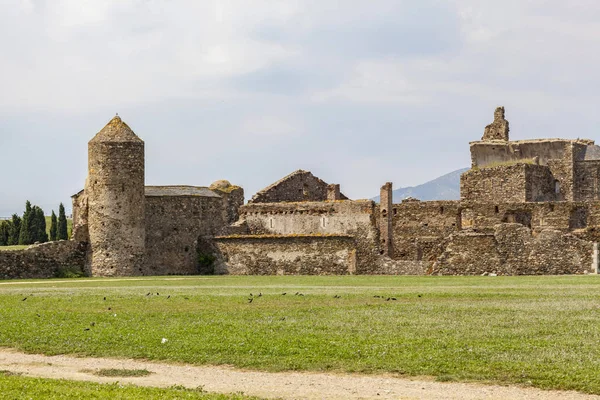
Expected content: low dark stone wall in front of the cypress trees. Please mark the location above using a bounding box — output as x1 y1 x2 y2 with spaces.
0 240 86 279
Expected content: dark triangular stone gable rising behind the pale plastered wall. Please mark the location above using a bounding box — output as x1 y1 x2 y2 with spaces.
249 169 348 203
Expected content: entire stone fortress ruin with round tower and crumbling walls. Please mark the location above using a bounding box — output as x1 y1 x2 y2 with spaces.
0 107 600 278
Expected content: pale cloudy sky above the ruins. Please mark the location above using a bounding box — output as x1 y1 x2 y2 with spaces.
0 0 600 216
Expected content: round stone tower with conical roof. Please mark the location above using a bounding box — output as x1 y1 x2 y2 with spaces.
85 116 146 276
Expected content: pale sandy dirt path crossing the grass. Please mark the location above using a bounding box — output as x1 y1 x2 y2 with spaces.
0 349 600 400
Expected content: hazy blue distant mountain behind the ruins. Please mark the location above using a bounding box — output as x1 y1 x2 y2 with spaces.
373 168 469 203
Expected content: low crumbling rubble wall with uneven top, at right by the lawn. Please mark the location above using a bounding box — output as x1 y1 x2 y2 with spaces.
432 224 593 275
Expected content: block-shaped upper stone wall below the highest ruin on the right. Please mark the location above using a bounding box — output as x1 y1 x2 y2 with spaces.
460 163 557 203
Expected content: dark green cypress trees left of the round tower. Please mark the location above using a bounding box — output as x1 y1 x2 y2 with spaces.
0 200 69 246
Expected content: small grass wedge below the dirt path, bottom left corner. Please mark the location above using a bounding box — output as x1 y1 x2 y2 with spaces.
0 371 256 400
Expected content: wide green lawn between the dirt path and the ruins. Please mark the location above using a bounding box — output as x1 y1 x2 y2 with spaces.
0 276 600 394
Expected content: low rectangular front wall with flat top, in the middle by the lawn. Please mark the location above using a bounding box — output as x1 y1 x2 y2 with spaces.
215 235 356 275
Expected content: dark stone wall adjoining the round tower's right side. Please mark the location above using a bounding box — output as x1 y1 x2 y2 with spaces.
146 196 227 275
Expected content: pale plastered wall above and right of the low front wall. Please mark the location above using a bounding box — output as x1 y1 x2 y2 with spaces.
240 200 379 274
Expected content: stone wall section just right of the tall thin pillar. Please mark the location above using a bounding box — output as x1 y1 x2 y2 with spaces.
392 201 460 271
